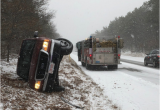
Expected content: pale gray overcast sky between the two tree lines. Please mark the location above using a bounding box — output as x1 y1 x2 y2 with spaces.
48 0 148 45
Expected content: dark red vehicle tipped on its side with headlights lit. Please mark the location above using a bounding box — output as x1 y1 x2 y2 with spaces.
17 31 73 92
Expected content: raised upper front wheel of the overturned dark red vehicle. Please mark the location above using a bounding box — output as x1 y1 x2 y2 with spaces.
56 38 73 55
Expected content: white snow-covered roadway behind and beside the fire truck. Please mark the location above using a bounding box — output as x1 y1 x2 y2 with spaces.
71 52 160 110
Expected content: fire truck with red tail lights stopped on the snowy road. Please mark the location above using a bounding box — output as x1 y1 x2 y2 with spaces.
76 35 124 69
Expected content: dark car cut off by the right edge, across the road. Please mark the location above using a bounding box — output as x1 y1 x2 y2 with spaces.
144 49 160 67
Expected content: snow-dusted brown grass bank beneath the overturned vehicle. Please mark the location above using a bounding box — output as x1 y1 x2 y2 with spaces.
0 56 120 110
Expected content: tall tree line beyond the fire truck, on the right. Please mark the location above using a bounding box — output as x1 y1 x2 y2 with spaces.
95 0 159 52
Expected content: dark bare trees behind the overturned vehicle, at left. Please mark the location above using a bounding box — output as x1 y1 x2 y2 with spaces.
1 0 60 61
